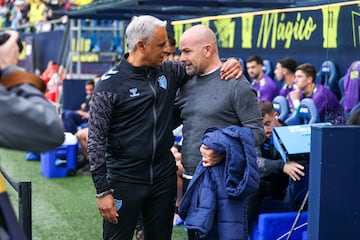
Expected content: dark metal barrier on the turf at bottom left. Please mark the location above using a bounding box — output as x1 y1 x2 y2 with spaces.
0 166 32 239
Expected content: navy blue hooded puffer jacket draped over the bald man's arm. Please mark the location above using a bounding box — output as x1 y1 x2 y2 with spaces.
179 126 259 240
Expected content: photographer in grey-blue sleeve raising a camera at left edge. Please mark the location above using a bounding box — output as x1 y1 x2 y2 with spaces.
0 31 64 152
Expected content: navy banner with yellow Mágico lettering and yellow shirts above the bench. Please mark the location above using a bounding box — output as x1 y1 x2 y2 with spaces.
172 1 360 74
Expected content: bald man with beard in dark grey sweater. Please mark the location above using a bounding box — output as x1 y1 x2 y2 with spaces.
175 25 265 239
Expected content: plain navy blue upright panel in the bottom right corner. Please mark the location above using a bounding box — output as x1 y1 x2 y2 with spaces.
308 126 360 240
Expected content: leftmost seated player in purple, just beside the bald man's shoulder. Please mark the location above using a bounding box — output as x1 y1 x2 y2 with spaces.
246 56 279 102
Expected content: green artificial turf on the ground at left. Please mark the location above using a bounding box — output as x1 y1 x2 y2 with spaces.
0 149 187 240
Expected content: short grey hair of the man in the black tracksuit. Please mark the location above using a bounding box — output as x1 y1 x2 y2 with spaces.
125 15 167 52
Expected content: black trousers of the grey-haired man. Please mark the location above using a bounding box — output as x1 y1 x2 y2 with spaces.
103 173 176 240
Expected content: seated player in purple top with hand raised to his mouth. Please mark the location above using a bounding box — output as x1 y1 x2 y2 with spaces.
289 63 345 124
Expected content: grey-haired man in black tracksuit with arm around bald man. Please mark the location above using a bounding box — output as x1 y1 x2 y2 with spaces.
88 15 240 240
